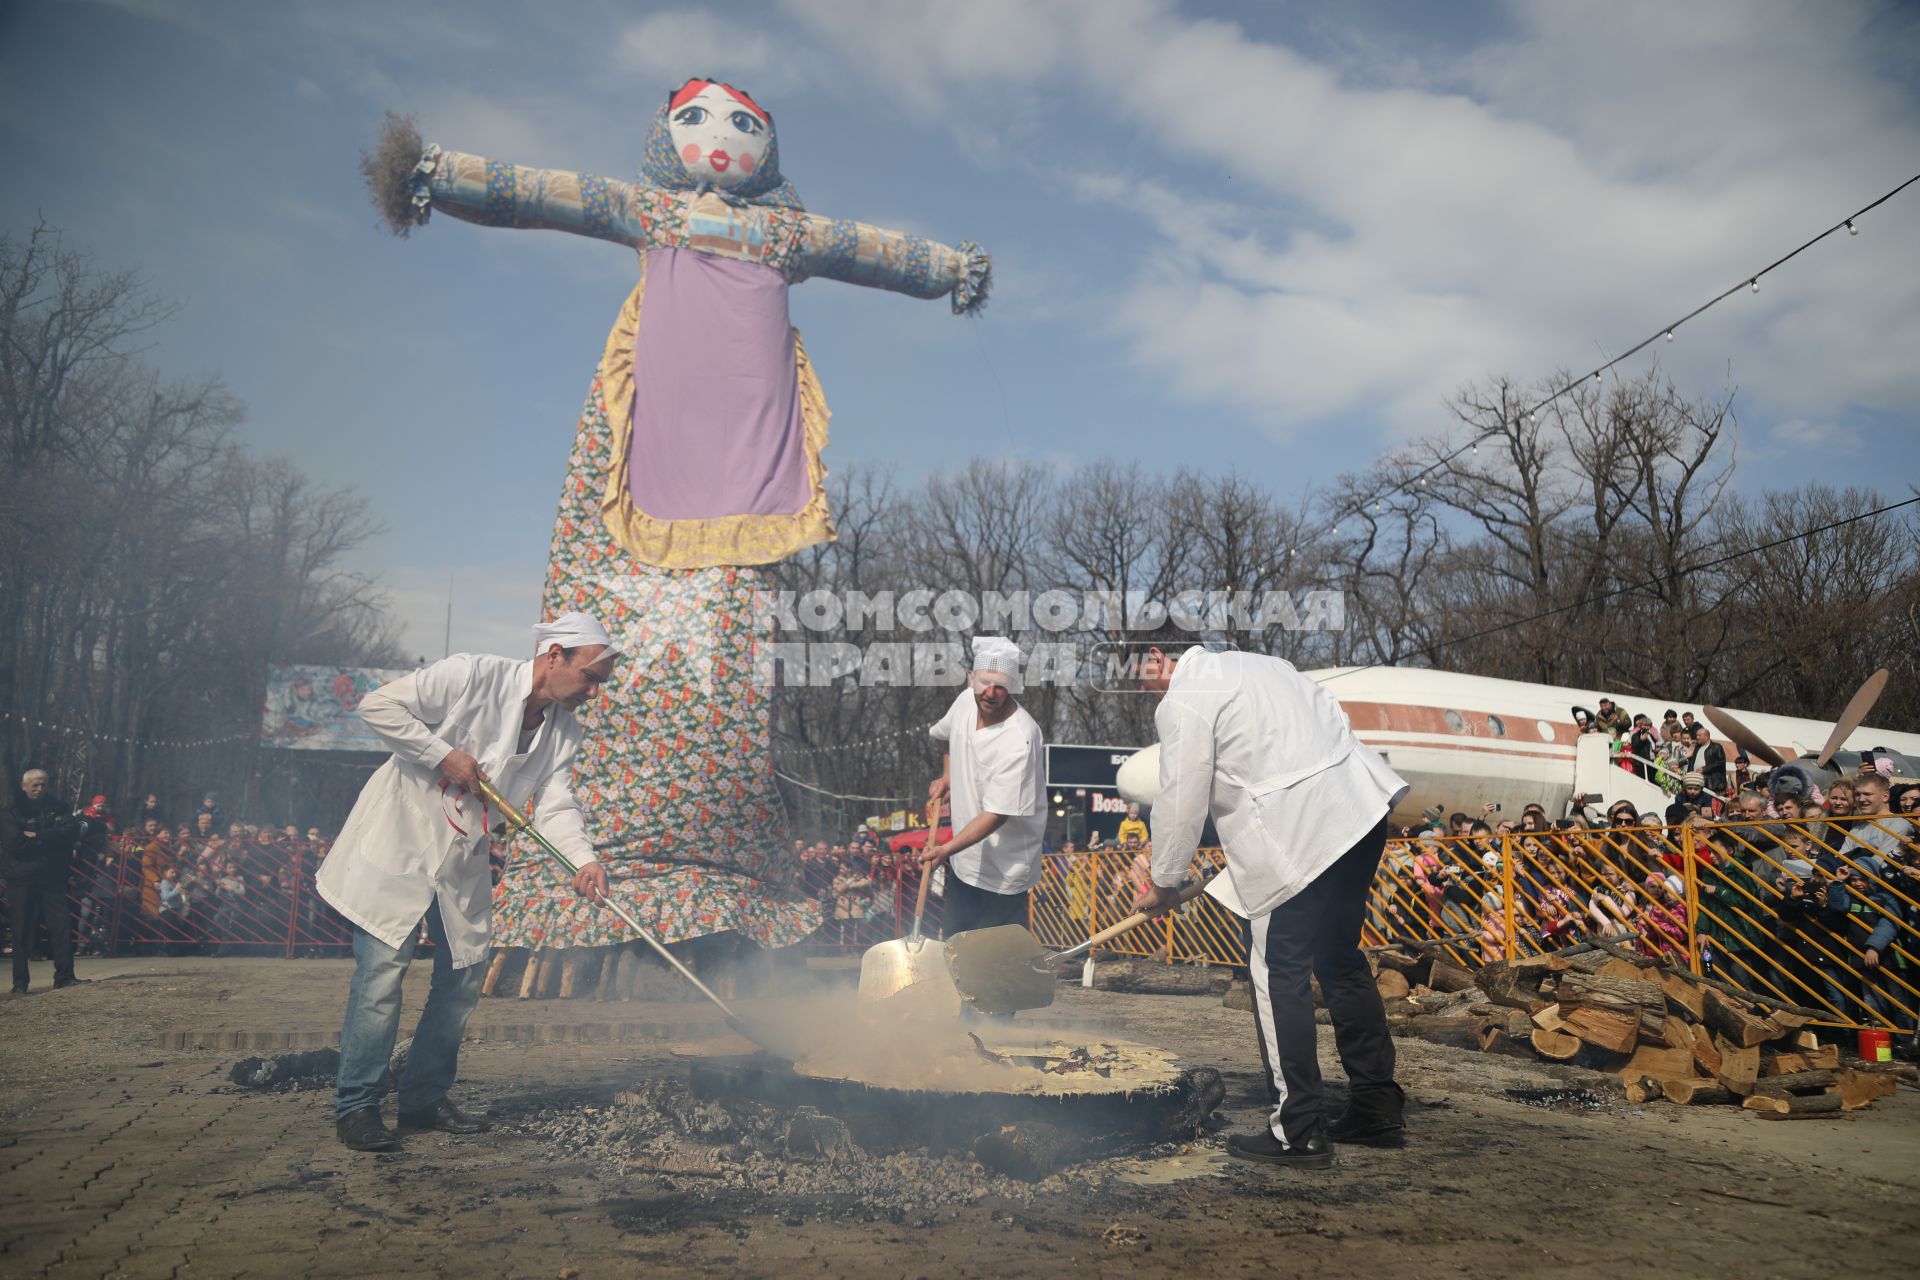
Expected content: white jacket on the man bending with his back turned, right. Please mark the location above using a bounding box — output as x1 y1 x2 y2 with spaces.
1152 649 1407 917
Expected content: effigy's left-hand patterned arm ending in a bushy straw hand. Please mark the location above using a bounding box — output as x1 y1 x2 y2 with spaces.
361 111 649 248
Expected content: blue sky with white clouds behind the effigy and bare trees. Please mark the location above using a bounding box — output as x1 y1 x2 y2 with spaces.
0 0 1920 656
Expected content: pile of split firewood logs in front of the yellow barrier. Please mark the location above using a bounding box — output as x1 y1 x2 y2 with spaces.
1377 942 1901 1119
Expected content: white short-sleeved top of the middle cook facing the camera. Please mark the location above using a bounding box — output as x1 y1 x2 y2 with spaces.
927 689 1046 894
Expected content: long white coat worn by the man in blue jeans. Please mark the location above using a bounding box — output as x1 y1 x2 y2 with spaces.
317 652 595 969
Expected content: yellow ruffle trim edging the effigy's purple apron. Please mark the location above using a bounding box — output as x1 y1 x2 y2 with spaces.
601 259 833 568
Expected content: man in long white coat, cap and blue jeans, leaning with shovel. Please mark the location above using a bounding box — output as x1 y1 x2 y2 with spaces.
317 614 618 1151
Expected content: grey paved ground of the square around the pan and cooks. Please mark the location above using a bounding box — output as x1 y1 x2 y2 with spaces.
0 958 1920 1280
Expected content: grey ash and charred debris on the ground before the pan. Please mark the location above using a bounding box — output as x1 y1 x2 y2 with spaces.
513 1080 1152 1224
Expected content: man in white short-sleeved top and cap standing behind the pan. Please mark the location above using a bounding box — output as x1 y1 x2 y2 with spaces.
922 635 1046 938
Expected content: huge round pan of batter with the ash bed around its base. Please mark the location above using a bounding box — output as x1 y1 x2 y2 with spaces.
518 1017 1225 1219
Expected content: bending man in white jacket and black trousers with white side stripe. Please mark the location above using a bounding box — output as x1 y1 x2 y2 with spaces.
1135 645 1407 1169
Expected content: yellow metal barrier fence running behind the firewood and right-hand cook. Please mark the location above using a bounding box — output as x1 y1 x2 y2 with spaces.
1031 816 1920 1034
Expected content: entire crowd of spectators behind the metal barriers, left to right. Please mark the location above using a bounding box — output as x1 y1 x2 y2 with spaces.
18 699 1920 1052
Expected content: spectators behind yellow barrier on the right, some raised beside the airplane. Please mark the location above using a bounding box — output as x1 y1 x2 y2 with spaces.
1373 700 1920 1054
